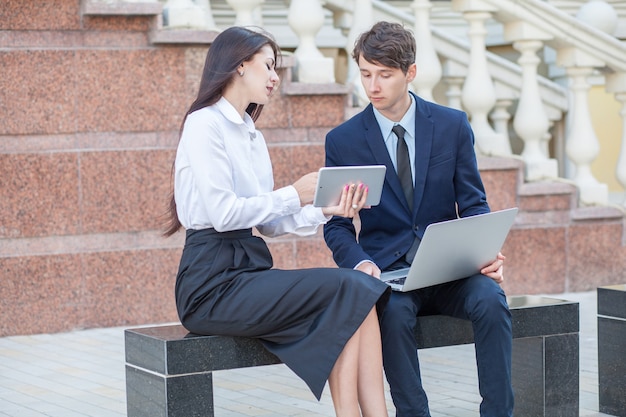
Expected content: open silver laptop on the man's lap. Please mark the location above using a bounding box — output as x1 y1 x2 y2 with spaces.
380 207 518 291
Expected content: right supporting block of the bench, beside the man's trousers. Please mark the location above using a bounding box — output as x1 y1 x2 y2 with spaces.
512 333 579 417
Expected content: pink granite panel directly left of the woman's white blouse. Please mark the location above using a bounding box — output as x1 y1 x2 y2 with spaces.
81 150 174 233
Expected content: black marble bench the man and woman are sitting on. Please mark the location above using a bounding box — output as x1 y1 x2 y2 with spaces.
125 296 579 417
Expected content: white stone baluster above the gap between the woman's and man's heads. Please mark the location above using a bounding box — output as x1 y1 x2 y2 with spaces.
287 0 335 83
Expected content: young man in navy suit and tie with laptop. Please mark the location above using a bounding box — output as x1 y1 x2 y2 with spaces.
324 22 513 417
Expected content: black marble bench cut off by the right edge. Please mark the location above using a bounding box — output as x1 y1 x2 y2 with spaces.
597 284 626 416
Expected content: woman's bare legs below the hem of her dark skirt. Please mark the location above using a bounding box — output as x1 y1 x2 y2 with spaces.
328 307 387 417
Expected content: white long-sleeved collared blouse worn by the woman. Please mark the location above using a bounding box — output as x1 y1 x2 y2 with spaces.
174 97 328 236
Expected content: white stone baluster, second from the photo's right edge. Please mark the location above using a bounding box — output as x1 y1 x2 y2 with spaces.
559 62 609 205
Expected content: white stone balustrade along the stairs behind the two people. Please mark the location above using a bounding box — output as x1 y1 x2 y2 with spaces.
144 0 626 205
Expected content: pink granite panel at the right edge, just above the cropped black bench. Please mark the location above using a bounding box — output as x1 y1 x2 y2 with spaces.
568 222 626 291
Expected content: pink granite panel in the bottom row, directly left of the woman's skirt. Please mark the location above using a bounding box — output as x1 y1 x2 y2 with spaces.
84 249 180 327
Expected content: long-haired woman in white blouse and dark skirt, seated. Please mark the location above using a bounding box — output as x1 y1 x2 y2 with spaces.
166 27 389 417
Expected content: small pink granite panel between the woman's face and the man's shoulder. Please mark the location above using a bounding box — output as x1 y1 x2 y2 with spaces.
289 95 345 127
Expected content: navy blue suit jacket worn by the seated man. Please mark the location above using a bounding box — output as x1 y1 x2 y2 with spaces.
324 93 489 270
